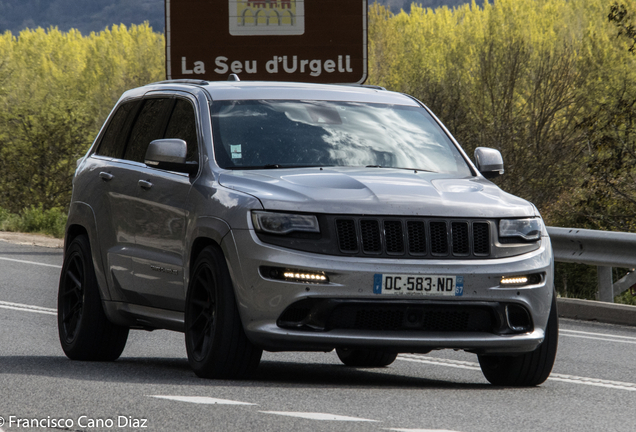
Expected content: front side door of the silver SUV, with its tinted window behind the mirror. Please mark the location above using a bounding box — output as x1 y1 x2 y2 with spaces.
128 96 199 311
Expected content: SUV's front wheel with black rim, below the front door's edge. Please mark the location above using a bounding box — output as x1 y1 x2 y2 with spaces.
185 246 263 379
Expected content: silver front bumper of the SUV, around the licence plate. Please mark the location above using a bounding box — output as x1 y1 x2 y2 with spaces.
223 230 553 354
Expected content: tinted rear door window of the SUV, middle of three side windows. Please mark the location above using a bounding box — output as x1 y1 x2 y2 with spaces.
124 99 174 162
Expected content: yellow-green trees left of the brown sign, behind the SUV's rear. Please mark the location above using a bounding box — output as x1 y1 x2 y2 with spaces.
0 23 164 213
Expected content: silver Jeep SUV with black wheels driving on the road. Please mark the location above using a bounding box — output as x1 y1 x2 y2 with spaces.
58 80 558 386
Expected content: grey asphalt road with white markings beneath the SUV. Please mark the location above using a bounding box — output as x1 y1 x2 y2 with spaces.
0 241 636 432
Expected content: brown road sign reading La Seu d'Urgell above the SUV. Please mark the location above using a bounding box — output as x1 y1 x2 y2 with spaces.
166 0 367 84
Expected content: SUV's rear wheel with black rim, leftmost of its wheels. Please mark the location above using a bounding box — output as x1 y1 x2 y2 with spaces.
57 235 128 361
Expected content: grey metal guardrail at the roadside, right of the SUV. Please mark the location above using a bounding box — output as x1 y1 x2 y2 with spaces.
547 227 636 303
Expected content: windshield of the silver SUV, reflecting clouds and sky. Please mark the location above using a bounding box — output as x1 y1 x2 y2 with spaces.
212 100 471 177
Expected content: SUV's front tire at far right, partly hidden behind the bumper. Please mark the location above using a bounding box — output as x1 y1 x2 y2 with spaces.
479 295 559 387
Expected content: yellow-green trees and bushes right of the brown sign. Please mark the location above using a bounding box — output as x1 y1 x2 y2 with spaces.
369 0 636 235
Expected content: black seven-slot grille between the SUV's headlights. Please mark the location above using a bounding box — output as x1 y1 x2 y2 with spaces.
335 217 490 258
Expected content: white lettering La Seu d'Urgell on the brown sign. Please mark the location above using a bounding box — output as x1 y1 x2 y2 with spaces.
181 55 353 77
